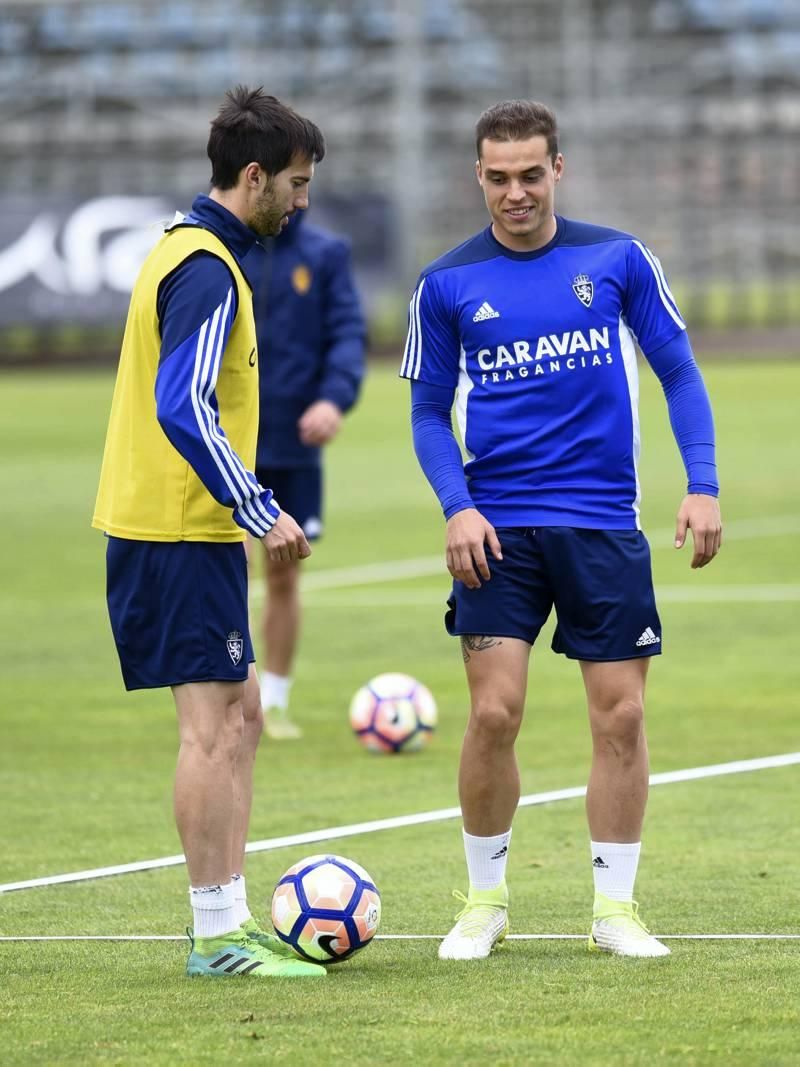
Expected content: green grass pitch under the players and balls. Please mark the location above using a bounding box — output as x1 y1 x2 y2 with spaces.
0 361 800 1065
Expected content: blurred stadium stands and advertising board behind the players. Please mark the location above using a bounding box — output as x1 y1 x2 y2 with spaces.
0 0 800 365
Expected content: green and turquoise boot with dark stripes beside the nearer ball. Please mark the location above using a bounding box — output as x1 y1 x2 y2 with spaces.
186 929 327 978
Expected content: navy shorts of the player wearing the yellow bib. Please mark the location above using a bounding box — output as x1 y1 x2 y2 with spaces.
106 537 255 689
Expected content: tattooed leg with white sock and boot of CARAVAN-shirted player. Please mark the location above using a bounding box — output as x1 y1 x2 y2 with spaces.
438 635 530 959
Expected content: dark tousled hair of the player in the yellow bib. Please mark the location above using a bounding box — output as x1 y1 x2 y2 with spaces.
207 85 325 189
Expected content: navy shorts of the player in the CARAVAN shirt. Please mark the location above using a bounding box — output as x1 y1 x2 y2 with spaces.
445 526 661 662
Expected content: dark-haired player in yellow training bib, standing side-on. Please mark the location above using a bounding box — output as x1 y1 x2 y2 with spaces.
93 86 325 977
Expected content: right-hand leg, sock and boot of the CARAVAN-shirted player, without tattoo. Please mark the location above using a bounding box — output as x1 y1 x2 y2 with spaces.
580 658 669 956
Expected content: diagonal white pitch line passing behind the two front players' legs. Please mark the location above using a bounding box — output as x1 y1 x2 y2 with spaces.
0 752 800 893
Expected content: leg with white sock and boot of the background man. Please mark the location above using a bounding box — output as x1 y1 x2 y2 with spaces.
261 553 301 740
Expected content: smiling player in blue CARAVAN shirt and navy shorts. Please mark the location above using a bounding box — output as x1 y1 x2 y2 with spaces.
401 100 721 959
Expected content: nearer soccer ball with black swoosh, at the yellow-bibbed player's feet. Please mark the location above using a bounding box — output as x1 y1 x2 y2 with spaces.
272 856 381 964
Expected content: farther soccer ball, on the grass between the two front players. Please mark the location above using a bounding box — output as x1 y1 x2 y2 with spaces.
350 674 437 752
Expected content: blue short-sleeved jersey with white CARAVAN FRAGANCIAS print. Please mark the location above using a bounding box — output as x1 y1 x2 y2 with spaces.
400 217 686 529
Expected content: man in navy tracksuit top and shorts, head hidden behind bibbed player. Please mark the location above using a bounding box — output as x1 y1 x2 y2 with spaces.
245 211 366 738
